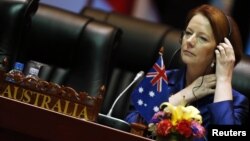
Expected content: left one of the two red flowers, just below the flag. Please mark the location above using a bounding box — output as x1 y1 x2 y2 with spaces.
156 119 173 136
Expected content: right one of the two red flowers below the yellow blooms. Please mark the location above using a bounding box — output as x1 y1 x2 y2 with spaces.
176 120 192 138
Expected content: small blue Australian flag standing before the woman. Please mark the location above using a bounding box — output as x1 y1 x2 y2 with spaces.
131 54 168 122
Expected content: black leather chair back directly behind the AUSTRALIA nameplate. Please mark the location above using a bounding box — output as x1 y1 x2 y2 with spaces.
17 4 120 96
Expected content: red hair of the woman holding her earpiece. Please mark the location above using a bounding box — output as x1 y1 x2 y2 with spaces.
185 4 243 65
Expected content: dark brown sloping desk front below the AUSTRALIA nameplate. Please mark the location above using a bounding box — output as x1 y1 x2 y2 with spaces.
0 96 152 141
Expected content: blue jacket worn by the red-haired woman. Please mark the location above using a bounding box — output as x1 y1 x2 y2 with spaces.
125 69 249 140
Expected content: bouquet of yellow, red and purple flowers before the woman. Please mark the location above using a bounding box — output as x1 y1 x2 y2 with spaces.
148 102 205 138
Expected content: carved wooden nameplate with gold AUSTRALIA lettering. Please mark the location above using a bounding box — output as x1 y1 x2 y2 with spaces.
0 72 102 121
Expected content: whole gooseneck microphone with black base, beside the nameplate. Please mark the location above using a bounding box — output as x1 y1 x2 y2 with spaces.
98 71 144 132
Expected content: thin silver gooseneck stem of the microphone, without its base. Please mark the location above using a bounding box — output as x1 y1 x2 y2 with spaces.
107 71 144 116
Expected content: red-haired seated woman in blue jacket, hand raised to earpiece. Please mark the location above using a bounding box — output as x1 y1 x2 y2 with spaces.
126 5 249 140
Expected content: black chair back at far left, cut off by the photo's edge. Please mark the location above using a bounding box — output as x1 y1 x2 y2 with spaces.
0 0 39 71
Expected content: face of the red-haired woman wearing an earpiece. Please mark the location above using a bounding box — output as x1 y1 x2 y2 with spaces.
181 14 216 67
